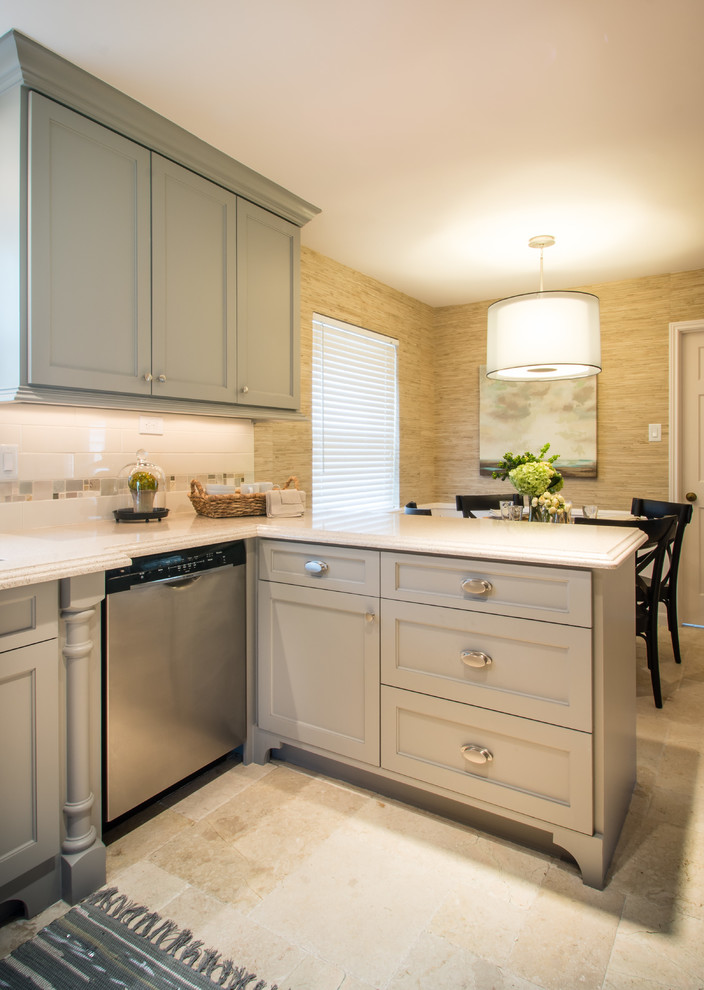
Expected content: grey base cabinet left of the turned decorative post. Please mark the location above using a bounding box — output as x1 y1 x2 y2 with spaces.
0 582 60 916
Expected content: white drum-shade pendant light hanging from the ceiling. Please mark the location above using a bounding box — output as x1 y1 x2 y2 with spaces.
486 234 601 382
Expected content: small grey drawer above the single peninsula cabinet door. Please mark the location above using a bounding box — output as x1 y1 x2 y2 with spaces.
259 540 379 596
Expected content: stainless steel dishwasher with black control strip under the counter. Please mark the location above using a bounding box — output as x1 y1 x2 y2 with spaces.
103 542 246 823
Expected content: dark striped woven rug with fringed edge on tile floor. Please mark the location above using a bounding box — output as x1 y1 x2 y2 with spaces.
0 887 278 990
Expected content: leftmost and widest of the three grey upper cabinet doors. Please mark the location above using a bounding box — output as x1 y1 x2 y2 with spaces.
27 93 151 394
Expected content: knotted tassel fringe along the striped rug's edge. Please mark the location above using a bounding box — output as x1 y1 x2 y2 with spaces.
85 887 278 990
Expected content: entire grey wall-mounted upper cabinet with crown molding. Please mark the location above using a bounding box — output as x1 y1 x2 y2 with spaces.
0 31 319 419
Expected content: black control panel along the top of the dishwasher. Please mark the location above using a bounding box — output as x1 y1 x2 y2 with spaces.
105 540 245 594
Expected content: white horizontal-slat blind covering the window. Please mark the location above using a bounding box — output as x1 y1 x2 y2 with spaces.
312 314 398 511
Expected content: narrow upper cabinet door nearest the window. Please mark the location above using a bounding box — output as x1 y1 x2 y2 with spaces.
237 199 300 409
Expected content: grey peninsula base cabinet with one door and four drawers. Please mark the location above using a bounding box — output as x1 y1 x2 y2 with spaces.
252 540 635 887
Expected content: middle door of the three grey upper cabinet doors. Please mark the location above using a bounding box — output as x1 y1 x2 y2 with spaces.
152 154 237 402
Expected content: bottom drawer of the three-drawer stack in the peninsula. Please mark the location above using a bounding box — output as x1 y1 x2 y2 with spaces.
381 687 593 835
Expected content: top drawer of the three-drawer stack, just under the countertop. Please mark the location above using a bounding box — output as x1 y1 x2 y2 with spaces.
381 553 591 626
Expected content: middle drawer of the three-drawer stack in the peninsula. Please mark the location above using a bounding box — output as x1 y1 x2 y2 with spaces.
381 599 592 732
